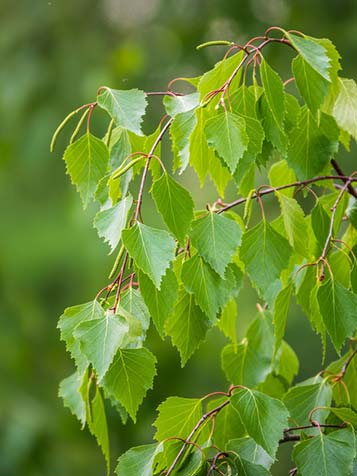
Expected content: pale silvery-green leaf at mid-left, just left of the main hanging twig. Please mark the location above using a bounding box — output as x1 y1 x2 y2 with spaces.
94 195 133 253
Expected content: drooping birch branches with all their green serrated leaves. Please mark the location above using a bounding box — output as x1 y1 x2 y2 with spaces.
52 28 357 476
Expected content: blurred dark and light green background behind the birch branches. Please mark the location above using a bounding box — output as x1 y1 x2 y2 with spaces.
0 0 357 476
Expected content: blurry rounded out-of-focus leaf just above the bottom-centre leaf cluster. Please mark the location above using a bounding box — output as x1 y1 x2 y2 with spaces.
221 313 274 387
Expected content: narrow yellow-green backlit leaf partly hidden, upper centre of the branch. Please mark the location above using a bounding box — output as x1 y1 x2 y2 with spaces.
189 107 214 187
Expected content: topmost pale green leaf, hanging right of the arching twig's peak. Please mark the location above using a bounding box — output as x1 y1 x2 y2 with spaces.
286 33 331 82
